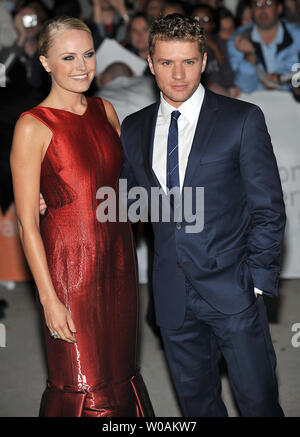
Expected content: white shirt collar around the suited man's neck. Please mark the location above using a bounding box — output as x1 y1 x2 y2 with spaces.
160 83 205 124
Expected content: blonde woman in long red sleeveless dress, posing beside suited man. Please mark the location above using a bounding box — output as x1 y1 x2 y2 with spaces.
11 18 153 417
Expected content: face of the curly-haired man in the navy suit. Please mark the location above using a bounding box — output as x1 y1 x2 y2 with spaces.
148 40 206 108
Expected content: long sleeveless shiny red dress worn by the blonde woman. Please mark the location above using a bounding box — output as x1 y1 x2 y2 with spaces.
22 98 153 417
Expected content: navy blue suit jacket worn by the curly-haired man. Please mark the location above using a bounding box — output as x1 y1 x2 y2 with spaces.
121 90 286 329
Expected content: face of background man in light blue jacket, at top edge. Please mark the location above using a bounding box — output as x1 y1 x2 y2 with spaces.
252 0 282 30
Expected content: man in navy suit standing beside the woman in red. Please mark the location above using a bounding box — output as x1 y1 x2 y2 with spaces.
121 15 285 417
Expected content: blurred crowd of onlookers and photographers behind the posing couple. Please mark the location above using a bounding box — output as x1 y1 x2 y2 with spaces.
0 0 300 98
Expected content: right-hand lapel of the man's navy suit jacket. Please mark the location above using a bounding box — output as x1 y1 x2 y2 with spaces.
183 89 218 187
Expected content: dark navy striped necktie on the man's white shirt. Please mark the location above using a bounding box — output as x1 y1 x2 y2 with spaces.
167 111 180 190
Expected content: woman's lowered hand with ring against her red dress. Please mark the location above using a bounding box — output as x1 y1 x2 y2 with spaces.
43 298 76 343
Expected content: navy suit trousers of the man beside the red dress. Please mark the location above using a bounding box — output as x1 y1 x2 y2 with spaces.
161 282 283 417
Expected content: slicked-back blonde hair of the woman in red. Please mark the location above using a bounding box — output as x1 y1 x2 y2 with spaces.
39 16 92 57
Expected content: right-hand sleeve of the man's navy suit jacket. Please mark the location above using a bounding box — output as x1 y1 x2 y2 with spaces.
240 106 286 296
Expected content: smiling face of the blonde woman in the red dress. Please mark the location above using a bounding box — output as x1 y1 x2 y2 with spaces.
40 29 96 93
